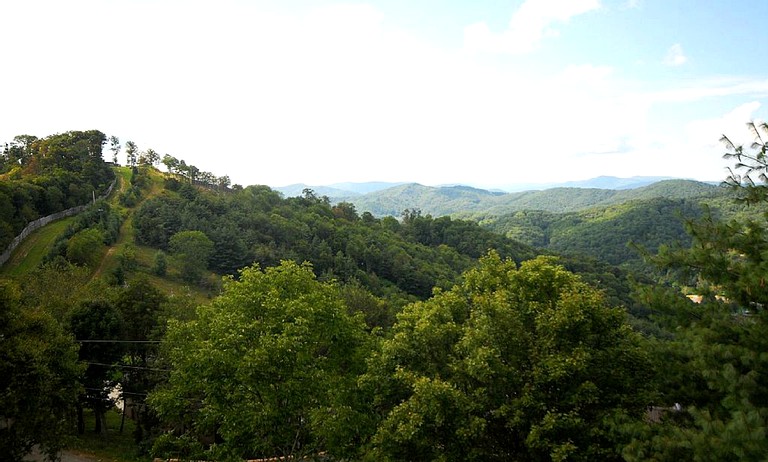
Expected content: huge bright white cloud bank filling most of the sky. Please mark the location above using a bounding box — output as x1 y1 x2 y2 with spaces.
0 0 768 187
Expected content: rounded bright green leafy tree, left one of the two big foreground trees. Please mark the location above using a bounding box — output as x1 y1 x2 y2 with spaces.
150 262 368 460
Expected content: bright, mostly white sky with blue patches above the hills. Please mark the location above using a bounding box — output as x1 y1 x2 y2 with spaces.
0 0 768 189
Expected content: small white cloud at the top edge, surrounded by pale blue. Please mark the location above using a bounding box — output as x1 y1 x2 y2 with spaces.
464 0 600 54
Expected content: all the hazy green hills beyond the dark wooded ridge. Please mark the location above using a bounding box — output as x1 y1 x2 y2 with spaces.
328 180 744 272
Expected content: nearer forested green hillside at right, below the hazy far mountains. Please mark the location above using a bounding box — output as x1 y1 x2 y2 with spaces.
473 181 768 273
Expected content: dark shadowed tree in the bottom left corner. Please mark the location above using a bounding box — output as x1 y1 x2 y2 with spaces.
0 280 82 462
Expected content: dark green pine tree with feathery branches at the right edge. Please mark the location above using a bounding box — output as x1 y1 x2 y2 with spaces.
624 123 768 461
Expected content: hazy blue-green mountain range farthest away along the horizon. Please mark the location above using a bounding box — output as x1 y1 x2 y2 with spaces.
275 177 722 217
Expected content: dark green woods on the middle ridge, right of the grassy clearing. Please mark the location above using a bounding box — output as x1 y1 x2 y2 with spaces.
134 178 534 304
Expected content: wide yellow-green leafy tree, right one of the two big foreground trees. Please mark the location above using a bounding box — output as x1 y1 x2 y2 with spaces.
362 253 650 461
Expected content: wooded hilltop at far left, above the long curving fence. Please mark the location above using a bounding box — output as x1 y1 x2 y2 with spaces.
0 130 114 249
